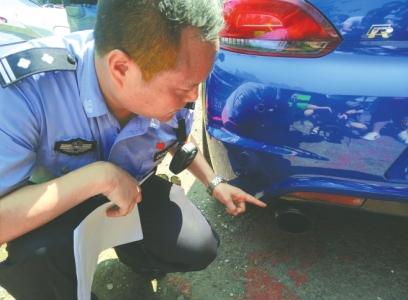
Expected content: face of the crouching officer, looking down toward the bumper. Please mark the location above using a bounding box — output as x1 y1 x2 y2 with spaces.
119 28 218 122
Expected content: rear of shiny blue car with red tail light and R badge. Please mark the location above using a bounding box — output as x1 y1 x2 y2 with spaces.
203 0 408 220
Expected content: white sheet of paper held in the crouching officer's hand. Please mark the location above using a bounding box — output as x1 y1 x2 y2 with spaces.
74 202 143 300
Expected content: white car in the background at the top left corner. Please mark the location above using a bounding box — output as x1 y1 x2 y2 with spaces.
0 0 70 35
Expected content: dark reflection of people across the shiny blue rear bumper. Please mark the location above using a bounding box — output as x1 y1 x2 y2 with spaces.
210 82 408 180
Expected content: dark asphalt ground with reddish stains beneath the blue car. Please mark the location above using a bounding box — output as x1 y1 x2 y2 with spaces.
0 100 408 300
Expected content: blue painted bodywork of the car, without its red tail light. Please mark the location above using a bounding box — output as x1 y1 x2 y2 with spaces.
204 0 408 212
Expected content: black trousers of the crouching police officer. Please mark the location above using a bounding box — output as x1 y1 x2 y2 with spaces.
0 176 219 300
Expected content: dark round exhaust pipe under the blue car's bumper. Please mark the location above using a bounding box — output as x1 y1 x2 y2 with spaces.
275 207 312 233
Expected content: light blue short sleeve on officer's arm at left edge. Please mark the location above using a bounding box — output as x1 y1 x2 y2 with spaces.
0 84 40 197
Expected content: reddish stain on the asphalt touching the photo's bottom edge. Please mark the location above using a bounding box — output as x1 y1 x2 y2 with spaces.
243 268 298 300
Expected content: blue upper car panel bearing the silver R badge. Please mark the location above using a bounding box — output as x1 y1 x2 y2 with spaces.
308 0 408 55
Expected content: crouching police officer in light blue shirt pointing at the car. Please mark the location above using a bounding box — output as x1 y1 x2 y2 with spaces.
0 0 265 299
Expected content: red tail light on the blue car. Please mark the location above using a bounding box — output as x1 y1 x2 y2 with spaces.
221 0 341 57
